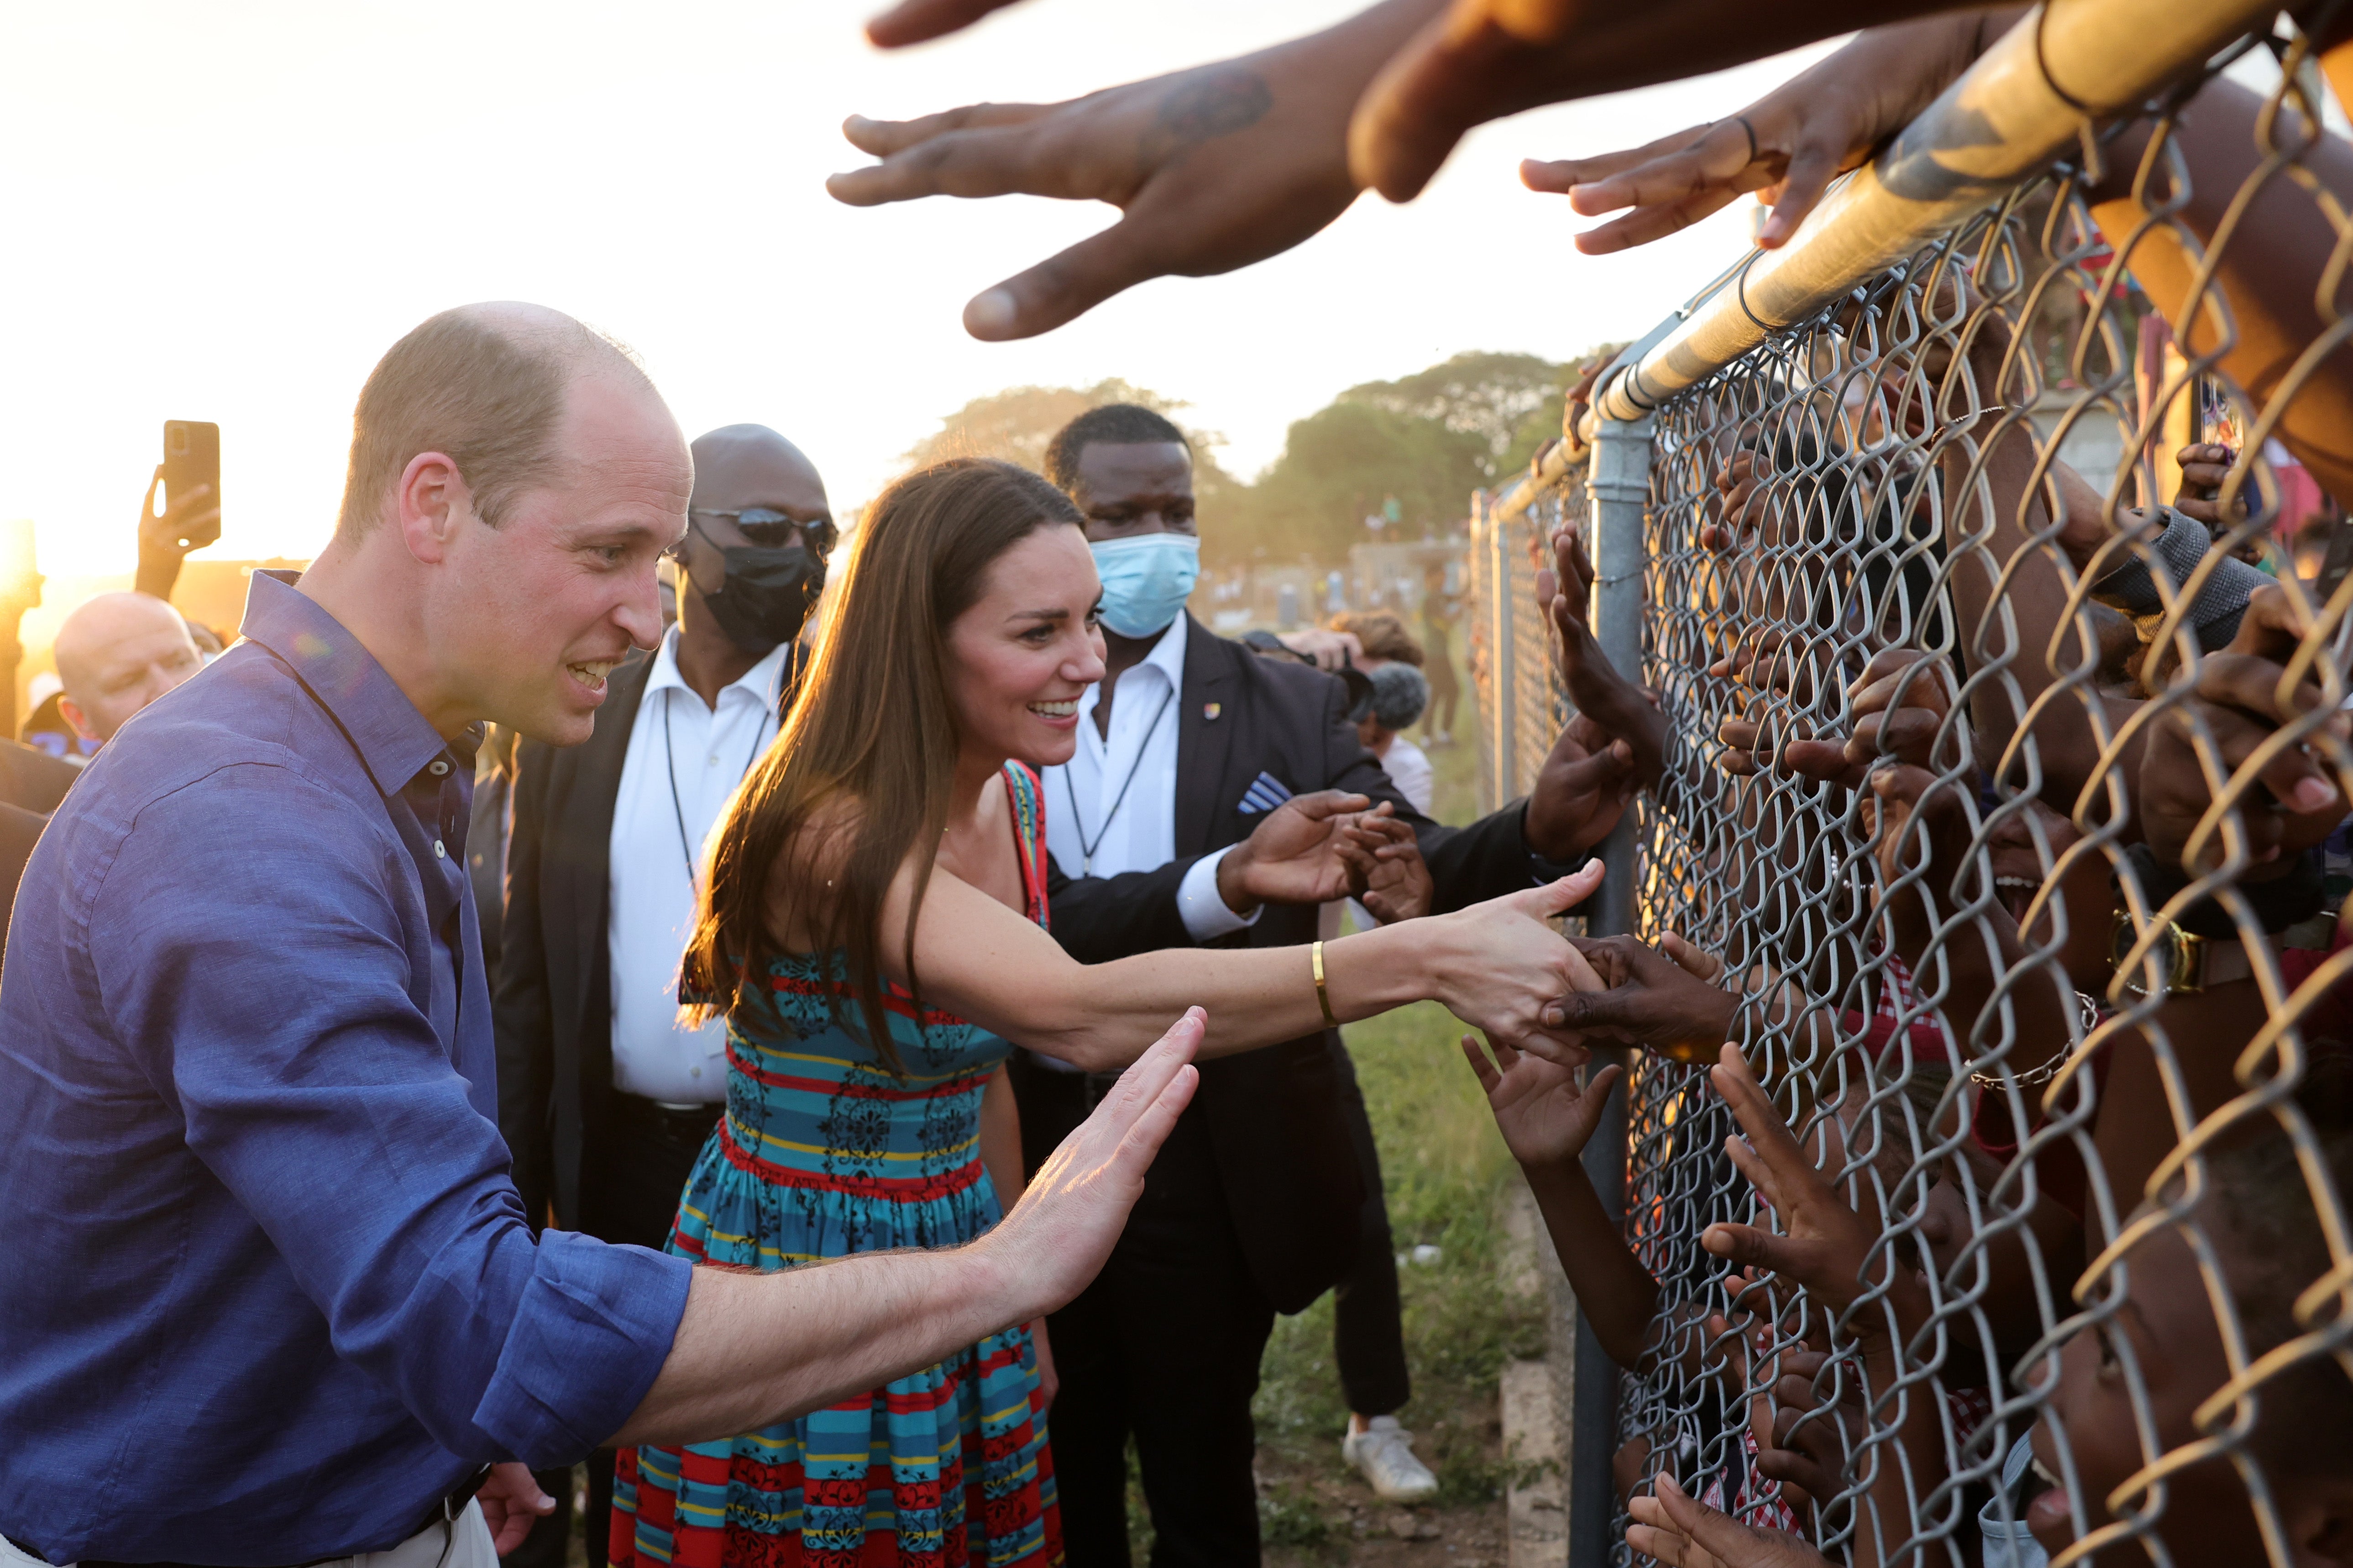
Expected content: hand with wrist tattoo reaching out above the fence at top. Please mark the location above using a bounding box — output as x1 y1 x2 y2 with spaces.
826 0 1436 341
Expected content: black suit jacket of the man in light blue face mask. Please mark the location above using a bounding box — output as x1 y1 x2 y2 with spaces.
1047 621 1539 1312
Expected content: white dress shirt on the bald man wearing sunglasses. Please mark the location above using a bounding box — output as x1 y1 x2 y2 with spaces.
605 625 791 1105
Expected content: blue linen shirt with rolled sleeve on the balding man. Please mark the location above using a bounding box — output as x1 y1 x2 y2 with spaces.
0 574 692 1566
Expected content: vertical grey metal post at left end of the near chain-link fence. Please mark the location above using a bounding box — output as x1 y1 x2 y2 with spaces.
1569 418 1652 1568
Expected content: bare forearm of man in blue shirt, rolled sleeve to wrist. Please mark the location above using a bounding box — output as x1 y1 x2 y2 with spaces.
607 1241 1030 1448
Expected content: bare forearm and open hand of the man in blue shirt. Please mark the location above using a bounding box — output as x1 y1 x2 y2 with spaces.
609 1009 1202 1448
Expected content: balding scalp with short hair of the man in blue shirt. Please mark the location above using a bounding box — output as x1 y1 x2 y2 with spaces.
336 301 652 541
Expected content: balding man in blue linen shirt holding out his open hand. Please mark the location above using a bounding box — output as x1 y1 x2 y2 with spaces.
0 306 1200 1568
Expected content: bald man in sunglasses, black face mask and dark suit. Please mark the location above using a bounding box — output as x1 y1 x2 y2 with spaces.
492 425 833 1563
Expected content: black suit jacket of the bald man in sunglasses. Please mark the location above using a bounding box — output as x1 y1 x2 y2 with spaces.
492 644 802 1229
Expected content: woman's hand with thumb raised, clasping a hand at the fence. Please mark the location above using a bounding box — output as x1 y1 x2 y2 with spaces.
1412 860 1603 1067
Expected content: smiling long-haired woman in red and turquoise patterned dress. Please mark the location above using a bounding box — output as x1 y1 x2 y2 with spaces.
612 461 1600 1568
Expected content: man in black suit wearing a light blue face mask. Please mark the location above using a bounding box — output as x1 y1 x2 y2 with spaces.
1014 404 1661 1568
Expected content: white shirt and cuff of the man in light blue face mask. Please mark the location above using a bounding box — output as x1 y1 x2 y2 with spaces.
1038 616 1259 1067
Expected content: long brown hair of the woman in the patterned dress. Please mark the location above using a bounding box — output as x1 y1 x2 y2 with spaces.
682 459 1080 1072
